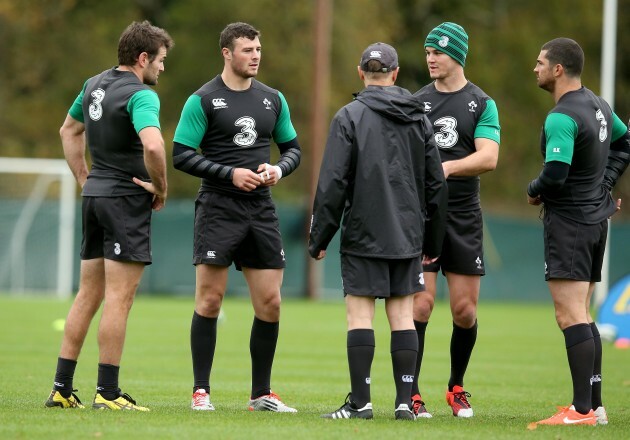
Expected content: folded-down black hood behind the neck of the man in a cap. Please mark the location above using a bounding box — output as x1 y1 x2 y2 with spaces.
354 86 424 124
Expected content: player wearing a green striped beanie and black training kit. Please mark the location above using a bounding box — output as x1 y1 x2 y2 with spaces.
412 22 500 417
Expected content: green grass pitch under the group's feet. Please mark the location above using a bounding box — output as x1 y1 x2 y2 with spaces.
0 295 630 440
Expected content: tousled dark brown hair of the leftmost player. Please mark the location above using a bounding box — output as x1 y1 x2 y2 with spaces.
118 20 175 66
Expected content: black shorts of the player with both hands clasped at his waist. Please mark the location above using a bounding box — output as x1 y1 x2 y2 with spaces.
193 192 285 270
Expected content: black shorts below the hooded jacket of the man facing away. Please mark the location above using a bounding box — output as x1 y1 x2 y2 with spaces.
341 254 424 298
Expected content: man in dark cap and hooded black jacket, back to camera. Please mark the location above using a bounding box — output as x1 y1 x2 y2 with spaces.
309 43 447 419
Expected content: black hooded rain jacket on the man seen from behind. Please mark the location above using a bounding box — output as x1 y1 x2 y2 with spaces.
309 86 448 259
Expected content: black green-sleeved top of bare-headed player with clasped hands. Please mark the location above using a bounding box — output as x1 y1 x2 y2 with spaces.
174 75 297 197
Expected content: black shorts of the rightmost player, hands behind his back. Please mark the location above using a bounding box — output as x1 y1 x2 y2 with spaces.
543 209 608 282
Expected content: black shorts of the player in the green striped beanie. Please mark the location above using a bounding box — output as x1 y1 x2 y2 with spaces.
424 209 486 275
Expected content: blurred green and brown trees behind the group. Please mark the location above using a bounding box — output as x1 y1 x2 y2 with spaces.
0 0 630 216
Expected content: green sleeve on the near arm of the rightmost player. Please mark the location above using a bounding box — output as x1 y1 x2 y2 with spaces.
545 113 578 165
